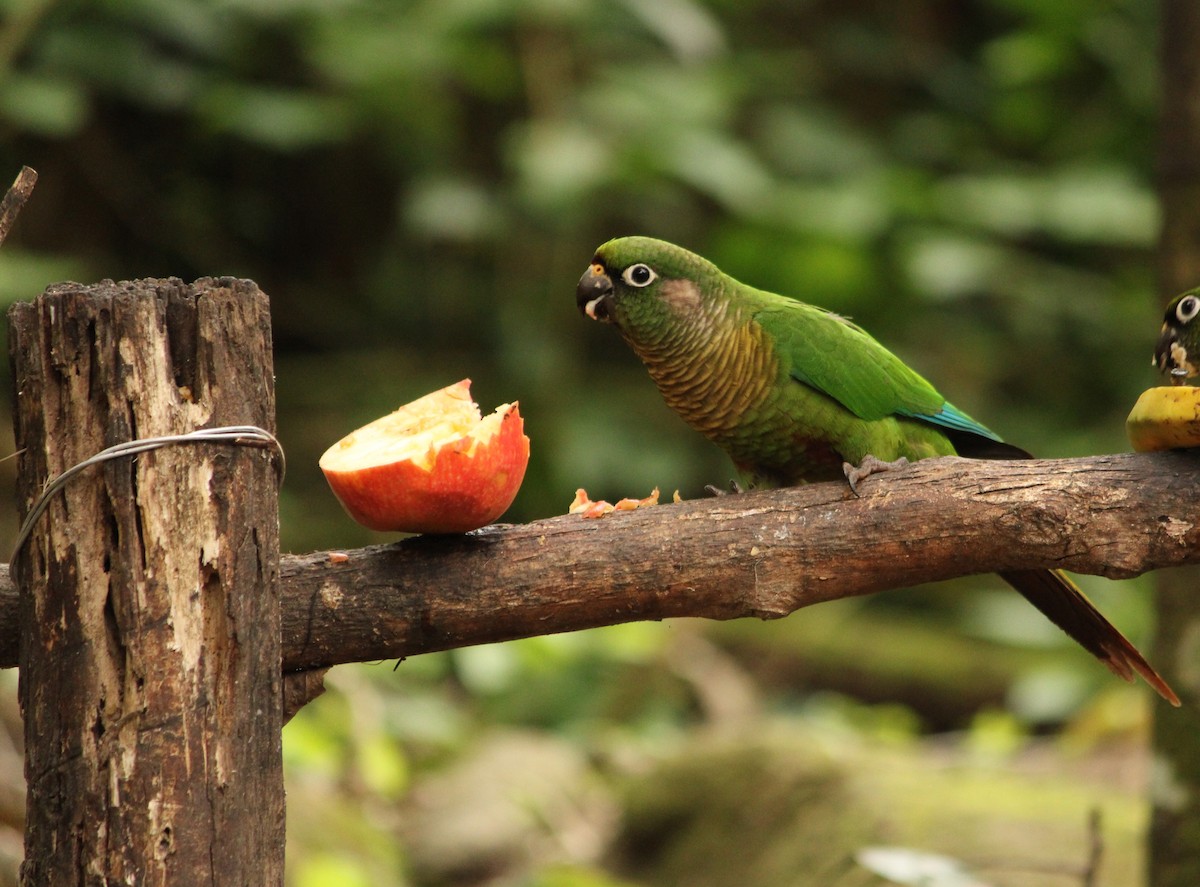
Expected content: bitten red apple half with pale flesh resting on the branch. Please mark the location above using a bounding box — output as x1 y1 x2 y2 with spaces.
320 379 529 533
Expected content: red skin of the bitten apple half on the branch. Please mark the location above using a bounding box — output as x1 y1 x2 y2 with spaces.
325 403 529 533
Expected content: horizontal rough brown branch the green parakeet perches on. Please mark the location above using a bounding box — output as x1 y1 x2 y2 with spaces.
7 453 1200 671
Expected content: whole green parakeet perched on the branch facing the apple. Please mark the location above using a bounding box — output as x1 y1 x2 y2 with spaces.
576 238 1178 705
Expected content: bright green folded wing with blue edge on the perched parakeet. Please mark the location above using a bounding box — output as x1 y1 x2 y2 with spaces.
752 294 1000 442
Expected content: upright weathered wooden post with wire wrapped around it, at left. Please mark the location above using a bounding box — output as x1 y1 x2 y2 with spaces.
8 278 284 887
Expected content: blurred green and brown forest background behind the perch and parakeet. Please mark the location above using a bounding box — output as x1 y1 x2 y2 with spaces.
0 0 1160 887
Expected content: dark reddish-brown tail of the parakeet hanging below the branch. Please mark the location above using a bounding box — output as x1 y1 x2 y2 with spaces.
1000 570 1180 706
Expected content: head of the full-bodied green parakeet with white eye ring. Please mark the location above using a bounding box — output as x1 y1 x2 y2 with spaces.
575 238 726 340
